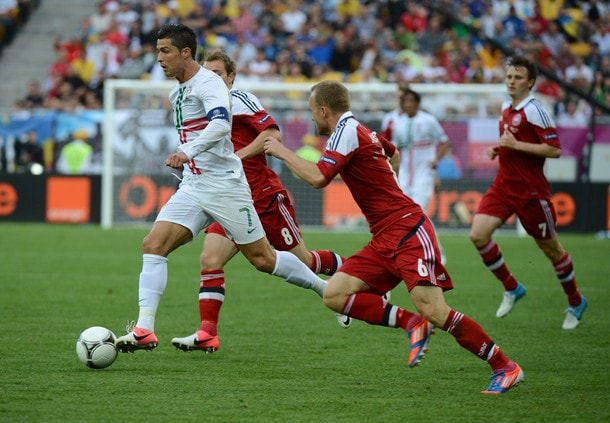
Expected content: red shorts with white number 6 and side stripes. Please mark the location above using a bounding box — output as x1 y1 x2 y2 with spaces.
340 214 453 293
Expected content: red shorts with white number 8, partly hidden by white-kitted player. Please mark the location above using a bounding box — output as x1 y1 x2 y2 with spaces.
205 191 303 251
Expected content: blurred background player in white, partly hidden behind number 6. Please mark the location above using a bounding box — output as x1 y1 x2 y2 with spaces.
381 88 451 263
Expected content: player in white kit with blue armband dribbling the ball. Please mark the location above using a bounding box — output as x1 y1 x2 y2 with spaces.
116 24 326 352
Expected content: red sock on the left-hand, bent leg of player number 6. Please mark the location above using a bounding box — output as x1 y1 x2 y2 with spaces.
342 292 414 330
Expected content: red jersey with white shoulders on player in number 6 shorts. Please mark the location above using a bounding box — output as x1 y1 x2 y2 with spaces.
318 112 423 234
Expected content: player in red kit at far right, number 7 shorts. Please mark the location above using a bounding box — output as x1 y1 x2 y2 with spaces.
470 56 587 329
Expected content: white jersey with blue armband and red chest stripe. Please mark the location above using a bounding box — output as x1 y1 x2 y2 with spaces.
169 67 243 179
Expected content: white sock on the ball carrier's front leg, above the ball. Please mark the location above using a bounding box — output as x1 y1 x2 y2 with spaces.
136 254 167 331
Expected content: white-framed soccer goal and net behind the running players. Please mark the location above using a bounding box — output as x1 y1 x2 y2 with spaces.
101 79 505 230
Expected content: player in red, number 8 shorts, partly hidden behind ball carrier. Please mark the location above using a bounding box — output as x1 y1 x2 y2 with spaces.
172 50 351 353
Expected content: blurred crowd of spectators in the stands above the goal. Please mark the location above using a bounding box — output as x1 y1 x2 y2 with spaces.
0 0 610 175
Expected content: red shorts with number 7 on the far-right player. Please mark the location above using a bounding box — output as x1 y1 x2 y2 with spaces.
477 186 557 239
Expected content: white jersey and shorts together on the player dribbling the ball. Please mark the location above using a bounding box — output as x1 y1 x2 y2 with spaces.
157 68 265 244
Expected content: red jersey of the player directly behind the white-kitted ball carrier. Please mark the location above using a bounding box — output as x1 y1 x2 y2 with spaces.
231 90 285 209
